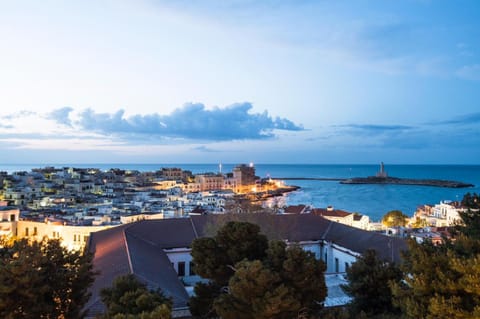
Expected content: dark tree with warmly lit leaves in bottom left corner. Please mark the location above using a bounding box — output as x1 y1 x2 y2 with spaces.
0 238 94 319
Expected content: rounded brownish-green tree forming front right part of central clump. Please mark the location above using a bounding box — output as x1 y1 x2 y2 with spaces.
214 241 326 319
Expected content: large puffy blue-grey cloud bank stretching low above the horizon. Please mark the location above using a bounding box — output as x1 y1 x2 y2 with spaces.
76 102 304 141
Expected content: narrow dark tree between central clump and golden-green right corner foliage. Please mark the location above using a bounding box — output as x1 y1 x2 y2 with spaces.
342 250 402 317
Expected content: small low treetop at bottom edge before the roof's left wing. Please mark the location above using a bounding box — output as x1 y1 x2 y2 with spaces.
100 274 172 319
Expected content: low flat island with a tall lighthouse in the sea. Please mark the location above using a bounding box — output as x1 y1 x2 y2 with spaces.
340 162 474 188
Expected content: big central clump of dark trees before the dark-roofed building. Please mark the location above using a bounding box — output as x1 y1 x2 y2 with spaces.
190 222 326 319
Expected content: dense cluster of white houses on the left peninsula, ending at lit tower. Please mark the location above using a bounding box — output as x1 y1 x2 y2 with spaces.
0 165 282 249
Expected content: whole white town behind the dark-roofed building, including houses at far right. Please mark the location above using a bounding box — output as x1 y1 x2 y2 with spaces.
0 164 472 249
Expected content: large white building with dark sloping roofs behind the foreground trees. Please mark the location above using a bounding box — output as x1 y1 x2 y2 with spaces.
86 214 406 318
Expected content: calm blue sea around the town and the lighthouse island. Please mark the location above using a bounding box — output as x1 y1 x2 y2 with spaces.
0 163 480 221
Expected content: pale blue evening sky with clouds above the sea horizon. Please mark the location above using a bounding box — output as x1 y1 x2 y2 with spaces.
0 0 480 164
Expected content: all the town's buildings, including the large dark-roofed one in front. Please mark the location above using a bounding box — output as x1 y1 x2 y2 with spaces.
0 164 476 318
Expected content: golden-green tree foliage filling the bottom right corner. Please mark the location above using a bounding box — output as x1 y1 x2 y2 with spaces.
392 235 480 319
